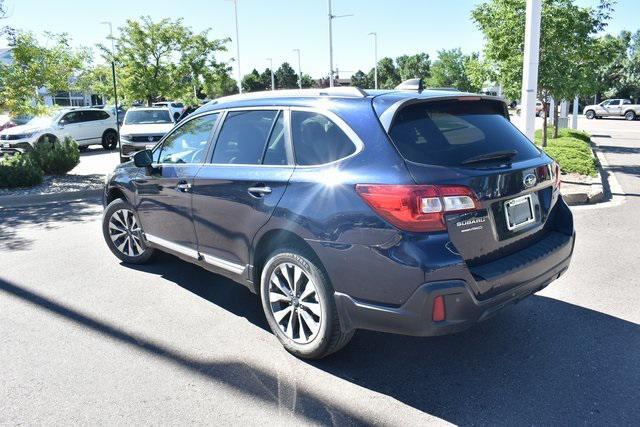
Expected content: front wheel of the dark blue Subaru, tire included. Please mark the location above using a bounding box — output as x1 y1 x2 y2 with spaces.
102 199 155 264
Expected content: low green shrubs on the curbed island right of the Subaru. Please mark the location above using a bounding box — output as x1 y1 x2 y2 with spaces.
535 128 598 176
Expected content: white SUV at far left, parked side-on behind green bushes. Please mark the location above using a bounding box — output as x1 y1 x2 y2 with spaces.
0 108 118 154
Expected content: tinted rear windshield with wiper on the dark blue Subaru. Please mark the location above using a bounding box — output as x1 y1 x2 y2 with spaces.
389 100 540 166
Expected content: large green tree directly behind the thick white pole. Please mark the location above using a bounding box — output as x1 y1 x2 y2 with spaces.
472 0 612 146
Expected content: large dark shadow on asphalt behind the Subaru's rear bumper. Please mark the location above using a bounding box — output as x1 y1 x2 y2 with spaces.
313 296 640 425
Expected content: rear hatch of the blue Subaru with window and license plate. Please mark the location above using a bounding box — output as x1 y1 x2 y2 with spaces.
389 97 558 295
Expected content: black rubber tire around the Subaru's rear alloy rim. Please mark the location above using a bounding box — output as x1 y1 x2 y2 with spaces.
260 248 355 359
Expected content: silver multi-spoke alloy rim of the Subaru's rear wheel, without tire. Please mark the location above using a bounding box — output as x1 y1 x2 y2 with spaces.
269 263 322 344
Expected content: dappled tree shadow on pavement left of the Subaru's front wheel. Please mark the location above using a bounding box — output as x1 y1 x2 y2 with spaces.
0 199 101 251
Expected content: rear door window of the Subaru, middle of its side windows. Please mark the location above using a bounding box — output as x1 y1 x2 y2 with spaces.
212 110 277 165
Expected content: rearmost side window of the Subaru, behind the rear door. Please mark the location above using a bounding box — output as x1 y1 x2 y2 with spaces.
291 111 356 165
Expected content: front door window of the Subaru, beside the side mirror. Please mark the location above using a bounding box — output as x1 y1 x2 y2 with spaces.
154 113 218 163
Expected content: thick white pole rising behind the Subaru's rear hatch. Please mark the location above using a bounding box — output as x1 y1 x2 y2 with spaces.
521 0 542 141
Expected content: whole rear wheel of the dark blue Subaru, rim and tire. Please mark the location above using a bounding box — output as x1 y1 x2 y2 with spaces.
260 249 354 359
